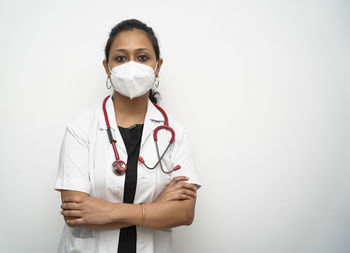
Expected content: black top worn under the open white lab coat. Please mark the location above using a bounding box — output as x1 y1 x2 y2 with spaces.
118 124 143 253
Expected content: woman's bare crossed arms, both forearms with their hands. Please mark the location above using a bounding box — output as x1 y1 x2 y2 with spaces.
61 177 196 229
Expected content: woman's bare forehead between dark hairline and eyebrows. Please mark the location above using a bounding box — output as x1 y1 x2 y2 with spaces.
110 29 154 52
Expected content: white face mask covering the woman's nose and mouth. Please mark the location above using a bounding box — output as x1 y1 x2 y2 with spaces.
108 61 158 99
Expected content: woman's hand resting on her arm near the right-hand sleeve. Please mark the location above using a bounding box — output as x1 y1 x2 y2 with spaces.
154 176 197 202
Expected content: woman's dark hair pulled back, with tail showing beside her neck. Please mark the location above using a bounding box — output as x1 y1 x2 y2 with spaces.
105 19 160 104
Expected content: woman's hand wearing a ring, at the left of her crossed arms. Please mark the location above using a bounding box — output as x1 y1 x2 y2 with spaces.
61 196 115 227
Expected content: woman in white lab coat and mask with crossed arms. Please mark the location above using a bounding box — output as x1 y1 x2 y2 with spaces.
55 19 200 253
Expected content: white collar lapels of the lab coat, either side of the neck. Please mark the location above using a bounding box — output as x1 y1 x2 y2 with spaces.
99 96 164 153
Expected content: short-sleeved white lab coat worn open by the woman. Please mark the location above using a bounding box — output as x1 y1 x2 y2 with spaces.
55 97 200 253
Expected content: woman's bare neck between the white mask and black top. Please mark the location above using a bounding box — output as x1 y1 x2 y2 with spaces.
112 91 148 127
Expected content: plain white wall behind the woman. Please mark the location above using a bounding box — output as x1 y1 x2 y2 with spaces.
0 0 350 253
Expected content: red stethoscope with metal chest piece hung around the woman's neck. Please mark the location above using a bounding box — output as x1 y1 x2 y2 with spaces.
102 96 181 175
